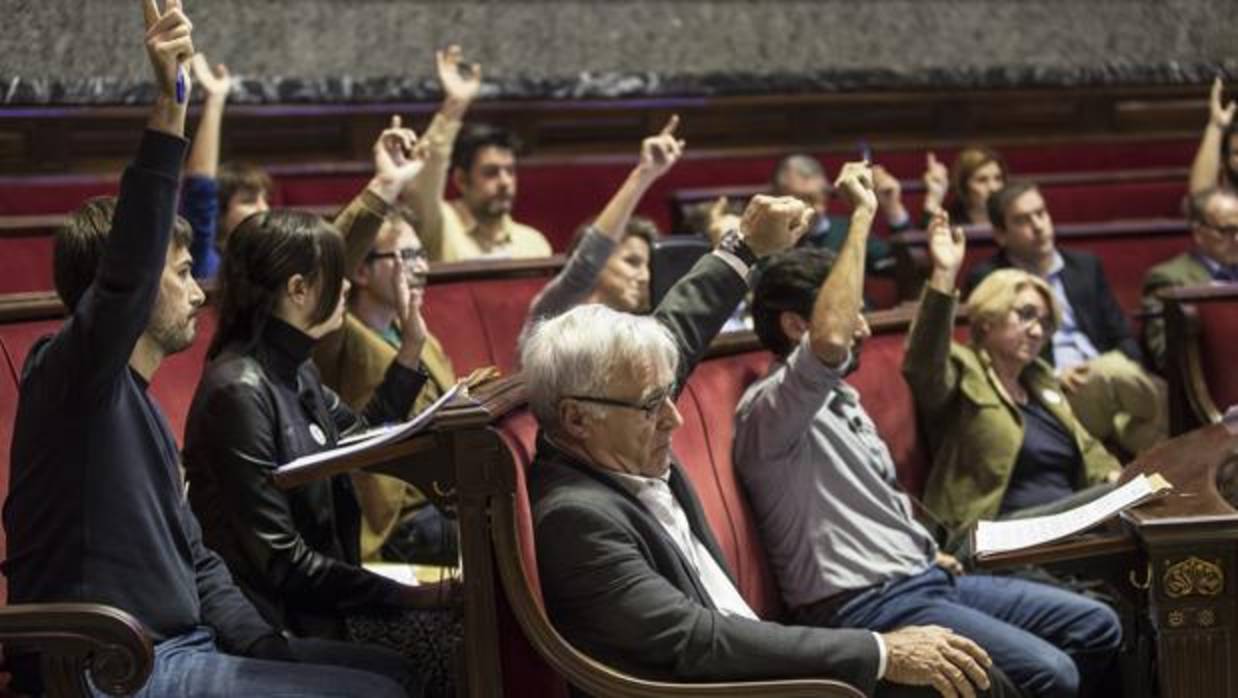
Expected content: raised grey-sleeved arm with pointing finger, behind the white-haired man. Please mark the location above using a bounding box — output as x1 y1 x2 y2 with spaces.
520 116 683 329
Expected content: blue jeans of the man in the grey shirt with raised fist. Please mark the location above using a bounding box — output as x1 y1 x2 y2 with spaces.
832 566 1122 698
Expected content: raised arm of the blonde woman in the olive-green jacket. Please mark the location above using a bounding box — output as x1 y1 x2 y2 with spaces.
903 210 967 412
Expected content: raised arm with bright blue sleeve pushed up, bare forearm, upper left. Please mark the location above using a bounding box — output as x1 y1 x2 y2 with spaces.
181 53 232 278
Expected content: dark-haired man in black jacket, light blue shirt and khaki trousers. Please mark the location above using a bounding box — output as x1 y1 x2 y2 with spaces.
966 182 1169 454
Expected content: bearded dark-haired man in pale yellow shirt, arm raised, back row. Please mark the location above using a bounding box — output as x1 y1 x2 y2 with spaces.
405 46 551 261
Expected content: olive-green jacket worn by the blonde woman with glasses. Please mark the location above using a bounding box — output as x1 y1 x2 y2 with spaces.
903 287 1120 532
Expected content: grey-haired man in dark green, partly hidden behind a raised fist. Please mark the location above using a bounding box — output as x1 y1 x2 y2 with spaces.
771 153 911 274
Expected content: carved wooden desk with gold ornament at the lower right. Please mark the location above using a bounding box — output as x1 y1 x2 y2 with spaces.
987 423 1238 698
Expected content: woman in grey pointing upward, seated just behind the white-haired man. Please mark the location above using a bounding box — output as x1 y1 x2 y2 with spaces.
520 116 683 344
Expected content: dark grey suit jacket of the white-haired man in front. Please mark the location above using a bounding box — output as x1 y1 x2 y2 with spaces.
530 255 878 694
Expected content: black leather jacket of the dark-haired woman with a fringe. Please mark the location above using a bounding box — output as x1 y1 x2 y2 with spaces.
184 318 426 637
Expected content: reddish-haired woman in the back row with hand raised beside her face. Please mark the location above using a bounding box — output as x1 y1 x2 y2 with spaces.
924 146 1010 226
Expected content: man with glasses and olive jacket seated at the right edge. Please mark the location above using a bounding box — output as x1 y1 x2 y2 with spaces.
1144 187 1238 371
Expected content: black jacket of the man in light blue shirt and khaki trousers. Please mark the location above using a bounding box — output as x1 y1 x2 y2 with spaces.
964 250 1143 364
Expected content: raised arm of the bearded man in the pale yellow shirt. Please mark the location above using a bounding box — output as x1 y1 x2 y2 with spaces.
404 46 482 259
